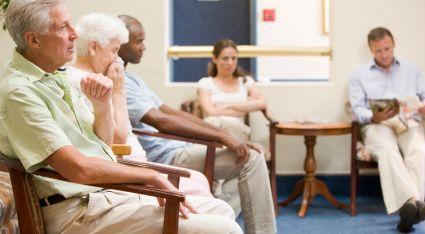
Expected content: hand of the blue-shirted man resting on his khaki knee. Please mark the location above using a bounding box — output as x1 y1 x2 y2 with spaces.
223 136 261 164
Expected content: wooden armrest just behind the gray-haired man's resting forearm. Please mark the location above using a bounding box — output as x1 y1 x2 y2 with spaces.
118 159 190 178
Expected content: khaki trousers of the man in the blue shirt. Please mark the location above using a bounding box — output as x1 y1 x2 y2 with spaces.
172 144 276 234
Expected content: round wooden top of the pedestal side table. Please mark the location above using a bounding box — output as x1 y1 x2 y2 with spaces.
272 122 351 136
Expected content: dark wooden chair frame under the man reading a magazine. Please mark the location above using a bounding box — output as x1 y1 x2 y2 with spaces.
350 121 378 216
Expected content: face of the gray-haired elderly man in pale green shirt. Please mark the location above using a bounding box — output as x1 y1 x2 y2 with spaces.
38 4 78 68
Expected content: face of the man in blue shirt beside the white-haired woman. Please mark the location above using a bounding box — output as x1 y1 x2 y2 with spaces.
118 23 146 64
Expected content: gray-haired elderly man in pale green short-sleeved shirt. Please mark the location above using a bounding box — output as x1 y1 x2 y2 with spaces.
0 0 241 233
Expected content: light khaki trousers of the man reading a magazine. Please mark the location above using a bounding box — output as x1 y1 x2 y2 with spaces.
362 124 425 214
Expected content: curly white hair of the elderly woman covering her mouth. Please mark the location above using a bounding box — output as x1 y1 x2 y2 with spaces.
75 13 129 55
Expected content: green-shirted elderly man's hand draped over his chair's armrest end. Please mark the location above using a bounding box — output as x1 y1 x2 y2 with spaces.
149 173 198 219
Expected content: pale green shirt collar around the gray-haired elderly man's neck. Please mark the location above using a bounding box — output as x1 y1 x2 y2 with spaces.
11 50 65 82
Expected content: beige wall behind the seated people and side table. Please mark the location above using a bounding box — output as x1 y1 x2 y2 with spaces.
0 0 425 174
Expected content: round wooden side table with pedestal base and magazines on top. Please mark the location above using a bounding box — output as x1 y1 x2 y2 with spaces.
270 122 351 217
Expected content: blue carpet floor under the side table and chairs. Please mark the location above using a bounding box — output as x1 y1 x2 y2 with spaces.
237 176 425 234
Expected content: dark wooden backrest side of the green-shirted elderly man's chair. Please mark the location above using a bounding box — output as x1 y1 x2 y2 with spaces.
0 153 45 234
